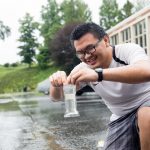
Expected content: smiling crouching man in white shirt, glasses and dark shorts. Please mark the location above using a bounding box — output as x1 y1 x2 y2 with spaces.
50 23 150 150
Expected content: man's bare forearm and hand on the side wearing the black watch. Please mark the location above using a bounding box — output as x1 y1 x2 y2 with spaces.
67 61 150 84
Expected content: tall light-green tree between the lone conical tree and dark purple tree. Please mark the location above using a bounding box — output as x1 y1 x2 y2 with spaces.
37 0 61 69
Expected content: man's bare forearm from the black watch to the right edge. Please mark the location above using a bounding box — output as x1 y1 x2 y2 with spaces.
103 61 150 84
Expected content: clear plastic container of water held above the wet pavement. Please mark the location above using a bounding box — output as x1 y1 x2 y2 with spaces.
63 84 80 118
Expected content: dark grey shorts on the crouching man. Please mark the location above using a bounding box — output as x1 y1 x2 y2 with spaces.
104 109 140 150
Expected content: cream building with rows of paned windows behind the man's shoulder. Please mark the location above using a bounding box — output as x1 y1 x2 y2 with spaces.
107 6 150 57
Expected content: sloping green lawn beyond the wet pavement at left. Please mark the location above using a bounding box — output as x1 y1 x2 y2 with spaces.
0 66 57 93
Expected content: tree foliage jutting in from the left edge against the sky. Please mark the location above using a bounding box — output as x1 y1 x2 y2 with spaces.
0 20 11 40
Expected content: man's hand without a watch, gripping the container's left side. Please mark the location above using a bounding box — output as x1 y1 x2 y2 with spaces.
49 71 67 87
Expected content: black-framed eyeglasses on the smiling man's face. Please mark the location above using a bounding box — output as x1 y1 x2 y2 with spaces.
76 39 102 59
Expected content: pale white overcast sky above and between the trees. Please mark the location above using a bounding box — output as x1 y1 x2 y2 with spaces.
0 0 131 64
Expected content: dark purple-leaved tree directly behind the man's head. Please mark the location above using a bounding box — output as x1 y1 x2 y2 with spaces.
51 22 79 73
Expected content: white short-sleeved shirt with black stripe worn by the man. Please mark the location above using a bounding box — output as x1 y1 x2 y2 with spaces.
75 43 150 120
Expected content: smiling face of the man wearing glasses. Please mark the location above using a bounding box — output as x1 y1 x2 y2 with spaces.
74 33 109 69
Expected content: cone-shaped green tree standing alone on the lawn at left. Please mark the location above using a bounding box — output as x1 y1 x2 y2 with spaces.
18 13 39 67
